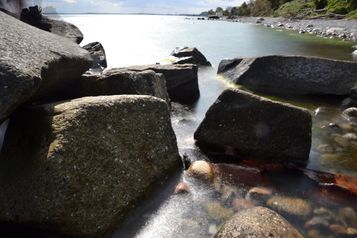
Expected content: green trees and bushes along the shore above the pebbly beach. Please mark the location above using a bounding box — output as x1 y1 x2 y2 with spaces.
201 0 357 18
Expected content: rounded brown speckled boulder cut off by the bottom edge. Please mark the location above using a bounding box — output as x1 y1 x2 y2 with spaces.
215 207 303 238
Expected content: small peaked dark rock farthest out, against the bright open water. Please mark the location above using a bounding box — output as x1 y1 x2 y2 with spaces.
171 47 211 66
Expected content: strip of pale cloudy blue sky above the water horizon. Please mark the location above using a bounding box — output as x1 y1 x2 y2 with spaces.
29 0 244 14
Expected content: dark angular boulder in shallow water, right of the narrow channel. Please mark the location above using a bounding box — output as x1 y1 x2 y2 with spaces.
194 89 312 163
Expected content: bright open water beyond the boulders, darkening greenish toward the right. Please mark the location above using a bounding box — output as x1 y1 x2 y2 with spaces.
51 14 352 67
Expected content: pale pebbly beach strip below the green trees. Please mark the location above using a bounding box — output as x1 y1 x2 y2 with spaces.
229 17 357 42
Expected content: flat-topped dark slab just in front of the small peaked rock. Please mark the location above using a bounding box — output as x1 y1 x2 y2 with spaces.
126 64 200 104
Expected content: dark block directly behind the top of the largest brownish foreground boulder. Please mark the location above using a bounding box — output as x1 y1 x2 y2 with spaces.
68 68 170 103
